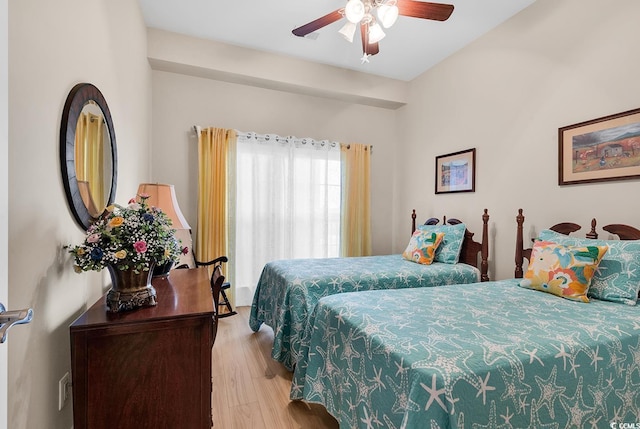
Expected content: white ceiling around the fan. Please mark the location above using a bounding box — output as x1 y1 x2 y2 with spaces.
138 0 535 81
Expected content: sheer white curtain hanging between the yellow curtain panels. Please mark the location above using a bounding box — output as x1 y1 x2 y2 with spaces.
235 132 340 305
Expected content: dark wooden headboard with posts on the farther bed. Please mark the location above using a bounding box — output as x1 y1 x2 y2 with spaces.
411 209 489 282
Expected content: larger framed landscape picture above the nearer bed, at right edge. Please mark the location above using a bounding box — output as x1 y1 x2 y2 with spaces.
558 109 640 185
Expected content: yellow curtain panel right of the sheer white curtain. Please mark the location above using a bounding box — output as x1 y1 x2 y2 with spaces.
340 143 371 256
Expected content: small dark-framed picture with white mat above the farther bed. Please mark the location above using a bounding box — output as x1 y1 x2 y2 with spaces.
436 148 476 194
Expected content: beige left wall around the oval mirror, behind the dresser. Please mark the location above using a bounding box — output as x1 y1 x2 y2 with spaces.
8 0 151 429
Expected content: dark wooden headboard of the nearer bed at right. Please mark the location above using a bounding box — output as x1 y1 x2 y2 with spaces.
515 209 640 279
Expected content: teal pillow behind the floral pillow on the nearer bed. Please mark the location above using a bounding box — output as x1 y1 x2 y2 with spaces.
539 230 640 305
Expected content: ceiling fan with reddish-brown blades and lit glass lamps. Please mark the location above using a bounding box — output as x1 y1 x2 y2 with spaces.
292 0 453 63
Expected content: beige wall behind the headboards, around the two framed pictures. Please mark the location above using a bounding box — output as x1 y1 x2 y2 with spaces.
394 0 640 278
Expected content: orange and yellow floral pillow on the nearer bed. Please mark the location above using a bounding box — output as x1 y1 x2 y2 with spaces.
520 240 608 302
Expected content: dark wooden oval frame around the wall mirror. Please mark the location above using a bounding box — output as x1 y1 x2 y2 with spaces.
60 83 118 230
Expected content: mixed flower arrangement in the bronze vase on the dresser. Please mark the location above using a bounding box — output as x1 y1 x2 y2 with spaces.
66 194 186 273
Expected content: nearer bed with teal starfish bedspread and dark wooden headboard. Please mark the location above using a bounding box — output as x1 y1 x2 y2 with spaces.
291 211 640 429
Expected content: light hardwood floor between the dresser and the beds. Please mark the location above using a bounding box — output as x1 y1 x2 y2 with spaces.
212 307 339 429
